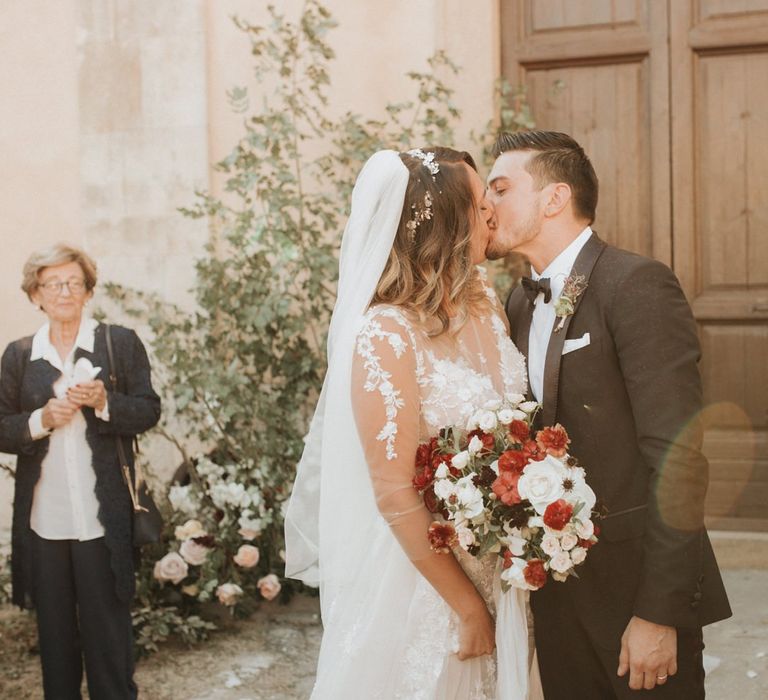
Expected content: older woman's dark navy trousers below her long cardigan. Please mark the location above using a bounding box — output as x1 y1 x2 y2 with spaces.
32 533 138 700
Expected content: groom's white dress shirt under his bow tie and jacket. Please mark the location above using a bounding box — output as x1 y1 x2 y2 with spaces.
528 226 592 402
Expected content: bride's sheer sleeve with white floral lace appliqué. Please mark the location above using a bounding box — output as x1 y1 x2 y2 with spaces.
352 309 432 560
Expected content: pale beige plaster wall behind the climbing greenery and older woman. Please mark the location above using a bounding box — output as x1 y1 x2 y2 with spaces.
0 0 499 528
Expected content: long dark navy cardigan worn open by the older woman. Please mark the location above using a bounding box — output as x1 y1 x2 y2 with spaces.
0 324 160 607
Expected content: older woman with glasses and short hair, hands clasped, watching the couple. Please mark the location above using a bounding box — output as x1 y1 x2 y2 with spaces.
0 244 160 700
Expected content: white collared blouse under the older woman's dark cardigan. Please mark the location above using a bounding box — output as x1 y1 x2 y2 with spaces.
29 318 109 541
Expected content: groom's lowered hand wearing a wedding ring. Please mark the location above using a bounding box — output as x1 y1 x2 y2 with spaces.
618 617 677 690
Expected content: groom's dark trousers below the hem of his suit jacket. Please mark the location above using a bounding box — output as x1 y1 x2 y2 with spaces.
534 596 704 700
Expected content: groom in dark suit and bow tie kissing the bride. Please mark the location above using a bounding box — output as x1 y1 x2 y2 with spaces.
488 131 731 700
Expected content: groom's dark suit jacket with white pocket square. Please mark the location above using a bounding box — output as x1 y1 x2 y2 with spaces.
506 234 731 653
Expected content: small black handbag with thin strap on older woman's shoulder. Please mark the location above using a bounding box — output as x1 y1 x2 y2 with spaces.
104 324 163 547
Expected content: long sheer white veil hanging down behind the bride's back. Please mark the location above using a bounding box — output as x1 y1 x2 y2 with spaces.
285 151 409 592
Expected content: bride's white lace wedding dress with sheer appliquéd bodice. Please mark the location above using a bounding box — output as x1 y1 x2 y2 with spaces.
312 276 528 700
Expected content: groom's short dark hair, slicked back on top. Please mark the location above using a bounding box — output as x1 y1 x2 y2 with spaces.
492 131 598 224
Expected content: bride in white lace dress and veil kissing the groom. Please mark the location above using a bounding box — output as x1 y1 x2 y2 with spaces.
286 148 529 700
